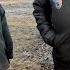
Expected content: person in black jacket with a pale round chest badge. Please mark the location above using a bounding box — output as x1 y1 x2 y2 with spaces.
33 0 70 70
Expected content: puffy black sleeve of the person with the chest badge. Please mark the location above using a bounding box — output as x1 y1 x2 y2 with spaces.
33 0 55 45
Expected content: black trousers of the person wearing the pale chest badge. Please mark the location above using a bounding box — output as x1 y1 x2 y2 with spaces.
52 48 70 70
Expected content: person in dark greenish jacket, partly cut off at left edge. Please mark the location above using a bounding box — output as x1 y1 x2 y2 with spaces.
0 5 13 70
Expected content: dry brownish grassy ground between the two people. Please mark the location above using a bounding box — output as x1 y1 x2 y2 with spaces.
0 0 53 70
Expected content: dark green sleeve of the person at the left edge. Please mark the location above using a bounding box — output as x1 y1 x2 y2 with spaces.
1 8 13 59
